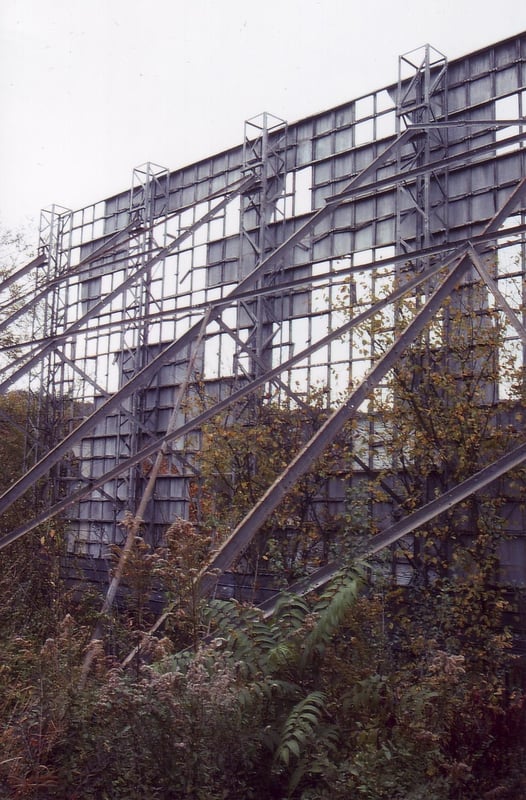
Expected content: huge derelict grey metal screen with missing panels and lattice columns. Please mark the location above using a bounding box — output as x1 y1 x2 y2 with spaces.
0 34 526 592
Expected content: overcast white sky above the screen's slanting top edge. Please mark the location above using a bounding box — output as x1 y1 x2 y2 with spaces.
0 0 526 236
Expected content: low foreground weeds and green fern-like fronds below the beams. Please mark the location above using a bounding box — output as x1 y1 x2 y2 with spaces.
0 565 526 800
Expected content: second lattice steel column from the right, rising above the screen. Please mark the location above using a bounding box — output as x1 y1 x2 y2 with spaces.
238 112 287 384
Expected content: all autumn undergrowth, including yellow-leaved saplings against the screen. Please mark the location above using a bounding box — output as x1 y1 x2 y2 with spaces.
0 242 526 800
